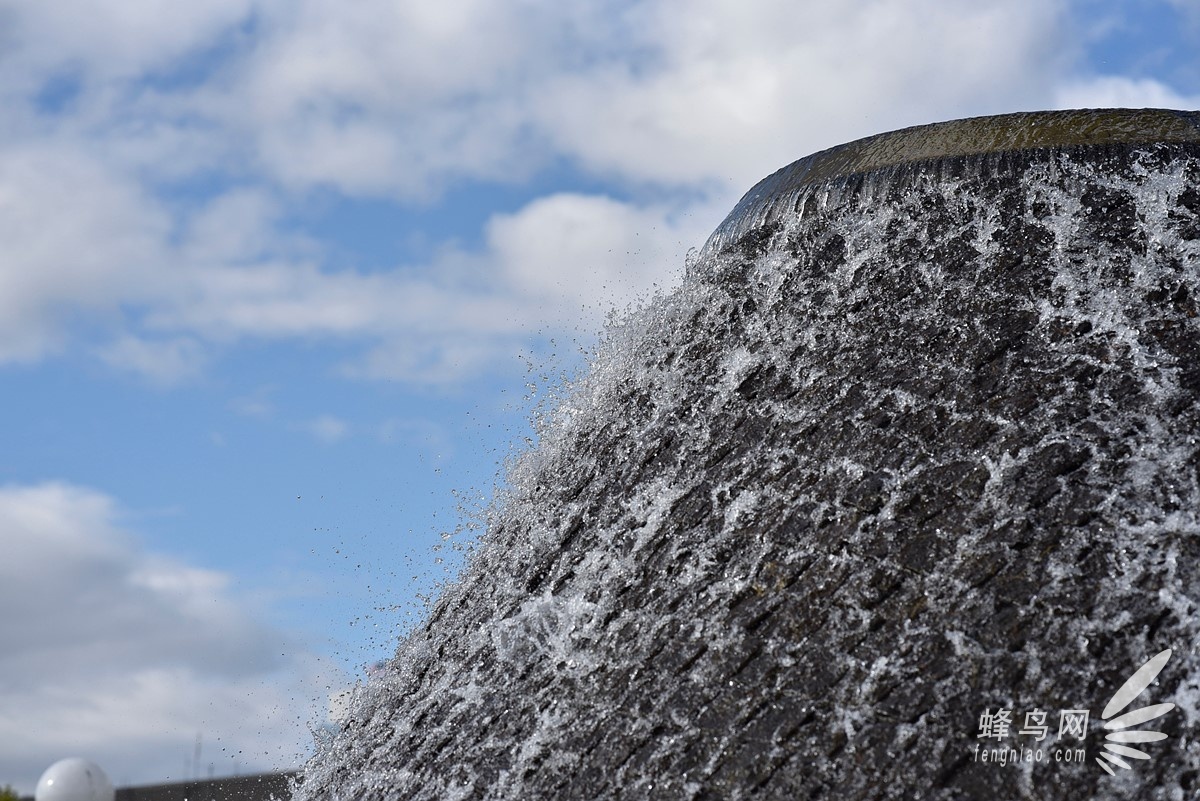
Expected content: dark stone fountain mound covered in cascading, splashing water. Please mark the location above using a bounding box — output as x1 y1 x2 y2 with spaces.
296 112 1200 800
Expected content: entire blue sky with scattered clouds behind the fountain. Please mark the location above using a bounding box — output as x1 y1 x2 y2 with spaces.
0 0 1200 791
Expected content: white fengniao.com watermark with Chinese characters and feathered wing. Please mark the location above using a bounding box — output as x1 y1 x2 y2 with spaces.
974 649 1175 776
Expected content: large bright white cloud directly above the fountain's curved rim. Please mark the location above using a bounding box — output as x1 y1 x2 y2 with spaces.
535 0 1062 186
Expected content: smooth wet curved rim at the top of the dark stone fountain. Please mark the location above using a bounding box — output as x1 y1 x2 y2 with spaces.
703 108 1200 253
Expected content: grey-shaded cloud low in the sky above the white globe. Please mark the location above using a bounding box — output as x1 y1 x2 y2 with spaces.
0 483 336 791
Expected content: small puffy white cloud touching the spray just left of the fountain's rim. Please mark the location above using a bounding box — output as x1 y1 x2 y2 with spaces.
328 193 726 384
